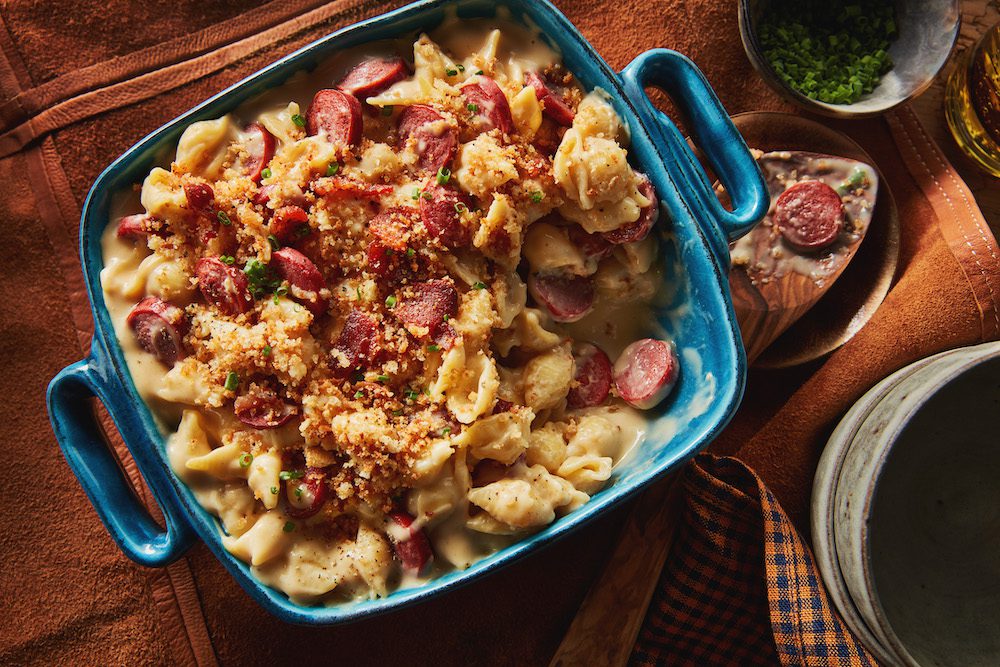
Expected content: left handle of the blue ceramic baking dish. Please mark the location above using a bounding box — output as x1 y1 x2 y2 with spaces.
48 357 194 567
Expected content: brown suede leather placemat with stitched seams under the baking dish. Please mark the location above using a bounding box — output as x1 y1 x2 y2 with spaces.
0 0 1000 665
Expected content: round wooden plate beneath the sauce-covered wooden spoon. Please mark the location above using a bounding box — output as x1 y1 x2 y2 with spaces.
733 112 899 368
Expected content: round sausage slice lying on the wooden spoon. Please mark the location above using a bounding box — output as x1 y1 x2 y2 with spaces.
774 181 844 250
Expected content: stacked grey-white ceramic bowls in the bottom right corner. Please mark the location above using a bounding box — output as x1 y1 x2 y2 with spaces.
812 342 1000 667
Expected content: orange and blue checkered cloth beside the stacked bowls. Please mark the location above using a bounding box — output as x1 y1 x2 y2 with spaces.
631 454 878 667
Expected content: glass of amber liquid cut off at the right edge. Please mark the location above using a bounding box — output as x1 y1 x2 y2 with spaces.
945 23 1000 177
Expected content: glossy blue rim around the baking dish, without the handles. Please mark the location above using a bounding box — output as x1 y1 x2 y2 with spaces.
64 0 746 625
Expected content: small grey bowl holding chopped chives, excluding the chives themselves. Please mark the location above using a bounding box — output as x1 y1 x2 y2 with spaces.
739 0 961 118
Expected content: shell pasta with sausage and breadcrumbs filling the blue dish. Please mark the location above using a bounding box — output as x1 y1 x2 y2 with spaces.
102 22 678 605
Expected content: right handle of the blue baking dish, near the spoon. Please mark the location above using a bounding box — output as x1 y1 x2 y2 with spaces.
621 49 770 267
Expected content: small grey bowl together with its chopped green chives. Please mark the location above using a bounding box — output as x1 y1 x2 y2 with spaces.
739 0 960 118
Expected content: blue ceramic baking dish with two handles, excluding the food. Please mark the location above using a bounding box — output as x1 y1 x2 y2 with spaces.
48 0 768 625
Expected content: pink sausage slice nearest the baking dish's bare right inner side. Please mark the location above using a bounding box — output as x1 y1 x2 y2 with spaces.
614 338 680 410
